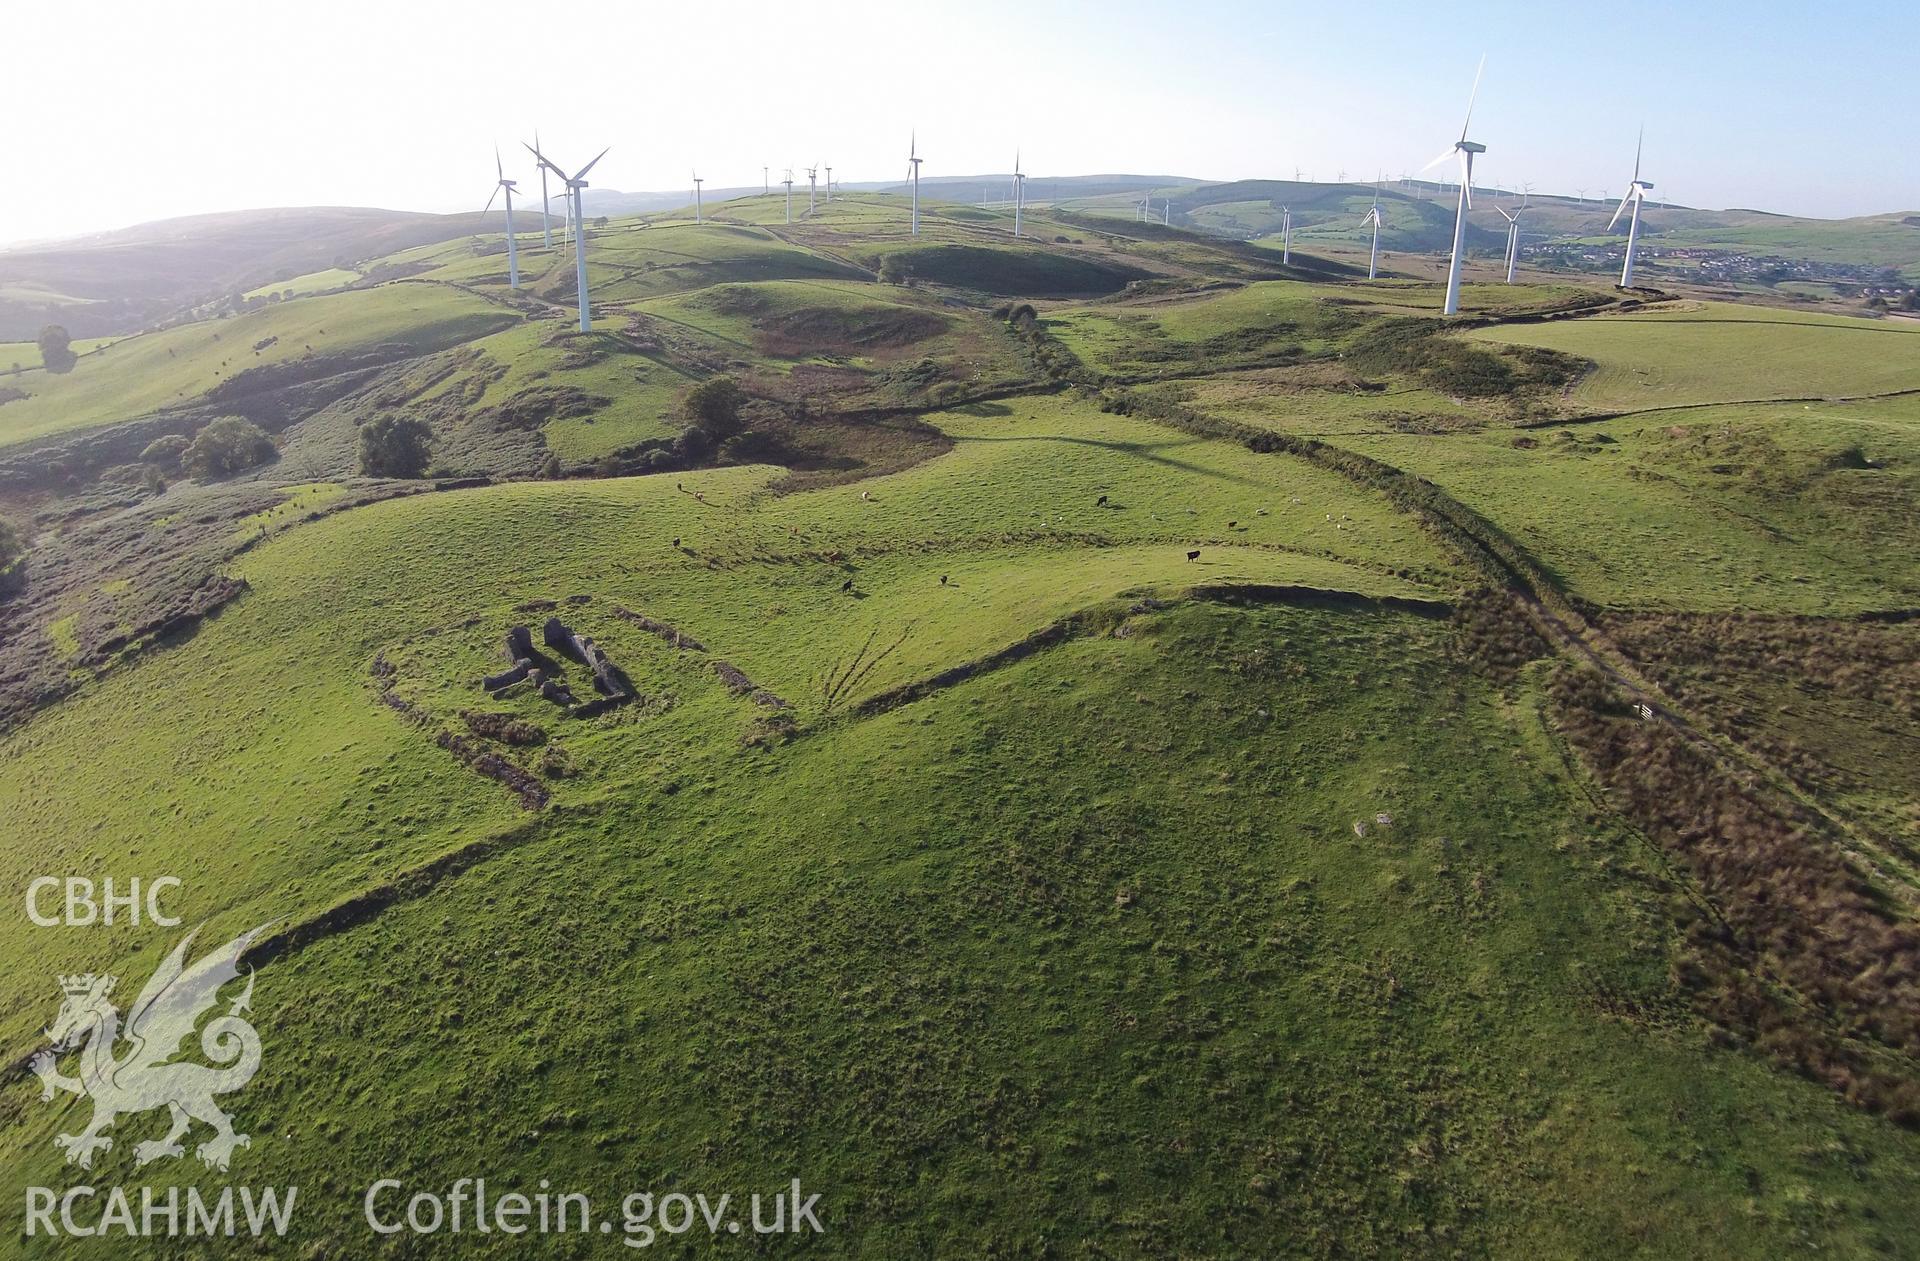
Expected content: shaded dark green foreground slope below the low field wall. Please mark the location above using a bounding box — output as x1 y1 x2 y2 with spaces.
6 608 1916 1257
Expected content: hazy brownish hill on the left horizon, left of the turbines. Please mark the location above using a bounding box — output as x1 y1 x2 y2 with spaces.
0 205 556 342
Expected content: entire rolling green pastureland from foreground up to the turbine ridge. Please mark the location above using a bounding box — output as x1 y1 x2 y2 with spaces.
0 190 1920 1259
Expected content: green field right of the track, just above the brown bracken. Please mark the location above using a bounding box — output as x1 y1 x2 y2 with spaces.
1334 391 1920 614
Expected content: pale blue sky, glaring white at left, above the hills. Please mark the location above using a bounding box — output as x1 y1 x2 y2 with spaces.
0 0 1920 240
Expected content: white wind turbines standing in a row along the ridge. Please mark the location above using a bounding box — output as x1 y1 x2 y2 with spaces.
480 56 1653 332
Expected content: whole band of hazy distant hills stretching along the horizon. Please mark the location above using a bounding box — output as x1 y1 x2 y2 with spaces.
0 171 1920 342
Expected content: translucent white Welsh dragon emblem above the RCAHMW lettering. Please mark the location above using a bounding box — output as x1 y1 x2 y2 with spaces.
27 923 271 1171
